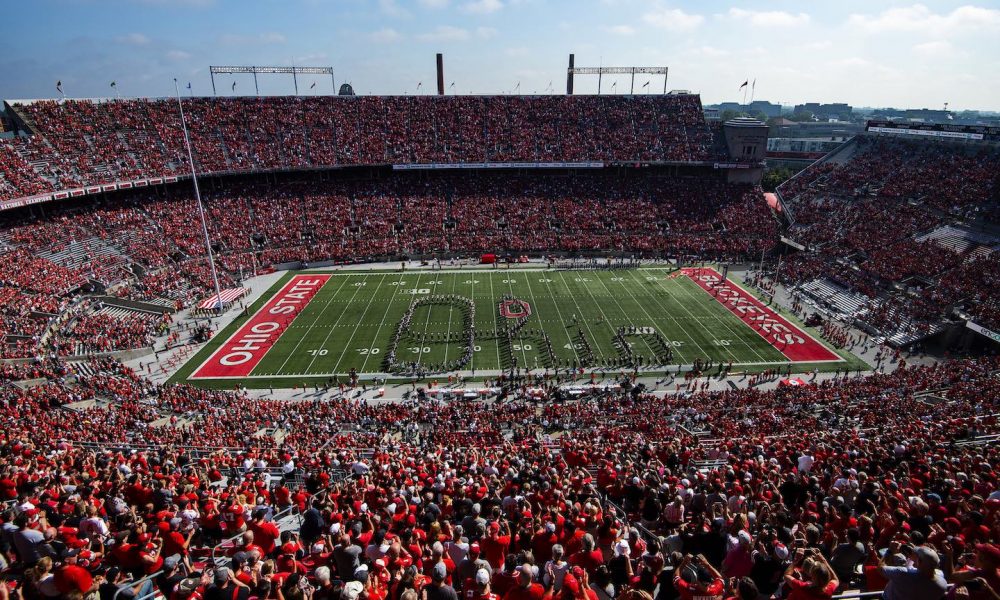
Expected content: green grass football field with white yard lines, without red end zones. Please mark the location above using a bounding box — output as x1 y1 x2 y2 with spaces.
173 269 868 387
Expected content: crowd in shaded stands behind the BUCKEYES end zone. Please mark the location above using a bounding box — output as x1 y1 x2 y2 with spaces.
779 136 1000 338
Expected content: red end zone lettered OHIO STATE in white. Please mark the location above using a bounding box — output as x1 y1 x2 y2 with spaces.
189 275 330 379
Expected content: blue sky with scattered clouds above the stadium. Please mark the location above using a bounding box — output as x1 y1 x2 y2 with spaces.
0 0 1000 110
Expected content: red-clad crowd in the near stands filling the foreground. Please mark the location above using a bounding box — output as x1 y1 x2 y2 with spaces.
0 352 1000 600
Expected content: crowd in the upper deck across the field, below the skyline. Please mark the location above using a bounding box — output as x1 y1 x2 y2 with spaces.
0 94 719 199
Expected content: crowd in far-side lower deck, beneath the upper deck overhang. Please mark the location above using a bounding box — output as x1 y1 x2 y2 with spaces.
0 173 777 357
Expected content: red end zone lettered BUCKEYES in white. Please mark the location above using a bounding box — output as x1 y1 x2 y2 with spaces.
681 269 843 362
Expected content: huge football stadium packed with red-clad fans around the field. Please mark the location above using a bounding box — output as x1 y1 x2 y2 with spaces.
0 2 1000 600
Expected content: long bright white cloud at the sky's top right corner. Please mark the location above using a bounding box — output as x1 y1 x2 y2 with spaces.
847 4 1000 36
